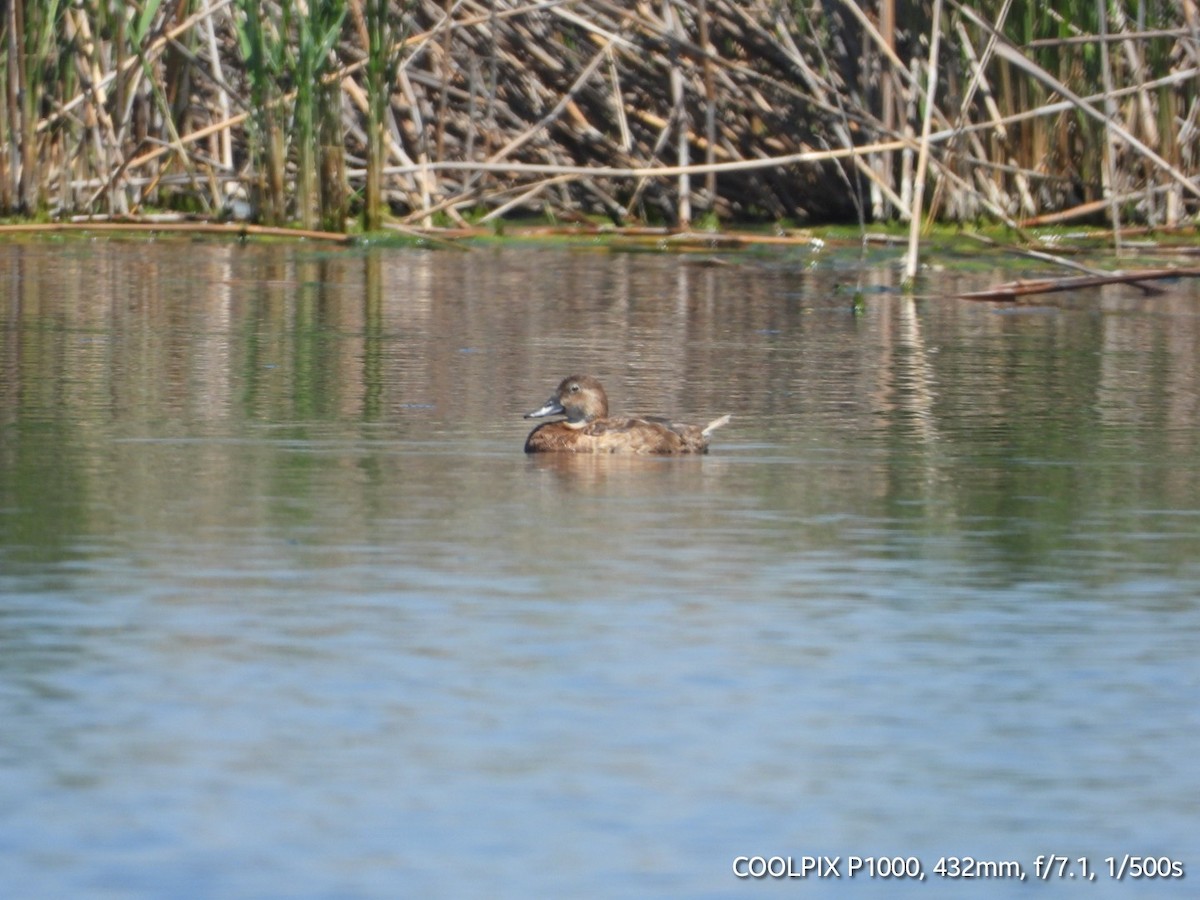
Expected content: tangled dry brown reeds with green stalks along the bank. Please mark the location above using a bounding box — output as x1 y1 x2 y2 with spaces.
0 0 1200 235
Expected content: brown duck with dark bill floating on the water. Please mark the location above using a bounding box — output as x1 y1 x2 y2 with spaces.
524 374 730 454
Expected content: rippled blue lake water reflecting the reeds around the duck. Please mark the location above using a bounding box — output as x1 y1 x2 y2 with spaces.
0 240 1200 898
